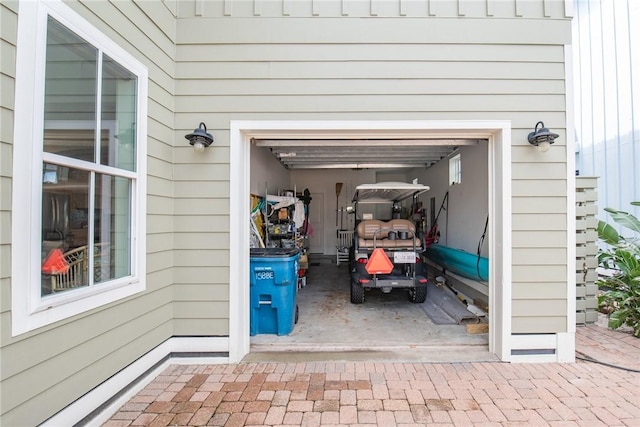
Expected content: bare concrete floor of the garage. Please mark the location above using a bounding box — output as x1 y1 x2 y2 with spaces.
244 255 497 362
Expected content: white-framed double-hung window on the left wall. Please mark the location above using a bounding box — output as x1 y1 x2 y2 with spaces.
12 1 147 335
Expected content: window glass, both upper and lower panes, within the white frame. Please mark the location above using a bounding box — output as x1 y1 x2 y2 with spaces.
41 17 138 296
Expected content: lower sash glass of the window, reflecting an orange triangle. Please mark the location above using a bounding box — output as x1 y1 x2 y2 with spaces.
41 169 132 295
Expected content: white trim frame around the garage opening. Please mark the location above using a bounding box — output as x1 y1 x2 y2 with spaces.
229 120 511 362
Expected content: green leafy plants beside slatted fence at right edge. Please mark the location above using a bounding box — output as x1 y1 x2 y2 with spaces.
597 202 640 337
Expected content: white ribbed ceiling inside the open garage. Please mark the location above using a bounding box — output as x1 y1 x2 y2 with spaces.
252 138 479 169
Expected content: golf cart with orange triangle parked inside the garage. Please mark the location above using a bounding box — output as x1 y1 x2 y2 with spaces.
349 182 429 304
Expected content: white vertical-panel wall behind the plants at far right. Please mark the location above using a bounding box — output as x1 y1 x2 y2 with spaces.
573 0 640 222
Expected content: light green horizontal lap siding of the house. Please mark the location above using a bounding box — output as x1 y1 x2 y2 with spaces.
0 0 573 425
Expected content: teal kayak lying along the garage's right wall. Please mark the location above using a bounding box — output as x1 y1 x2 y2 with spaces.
424 244 489 282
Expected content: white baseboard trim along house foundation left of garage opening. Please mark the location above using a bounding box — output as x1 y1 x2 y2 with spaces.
42 337 229 427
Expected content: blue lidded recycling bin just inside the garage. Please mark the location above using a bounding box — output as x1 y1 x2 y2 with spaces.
250 248 300 336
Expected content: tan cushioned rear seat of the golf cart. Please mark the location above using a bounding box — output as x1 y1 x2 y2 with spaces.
356 219 420 249
